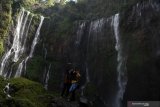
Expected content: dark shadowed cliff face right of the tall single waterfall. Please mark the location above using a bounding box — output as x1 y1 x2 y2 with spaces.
120 0 160 103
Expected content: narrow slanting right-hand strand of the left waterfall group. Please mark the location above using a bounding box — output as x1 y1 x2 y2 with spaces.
15 16 44 77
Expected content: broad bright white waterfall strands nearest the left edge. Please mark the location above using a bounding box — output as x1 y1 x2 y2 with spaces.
0 8 30 76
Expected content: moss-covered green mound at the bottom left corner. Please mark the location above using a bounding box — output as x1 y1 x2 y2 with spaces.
0 77 51 107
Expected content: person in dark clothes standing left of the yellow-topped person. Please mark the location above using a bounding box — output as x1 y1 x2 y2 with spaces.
61 63 73 97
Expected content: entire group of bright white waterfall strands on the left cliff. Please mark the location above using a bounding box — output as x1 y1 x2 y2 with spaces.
0 8 44 77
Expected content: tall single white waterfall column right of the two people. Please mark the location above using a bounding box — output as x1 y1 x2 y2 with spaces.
111 14 127 107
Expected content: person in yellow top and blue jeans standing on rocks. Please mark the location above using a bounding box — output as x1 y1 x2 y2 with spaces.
68 68 81 101
